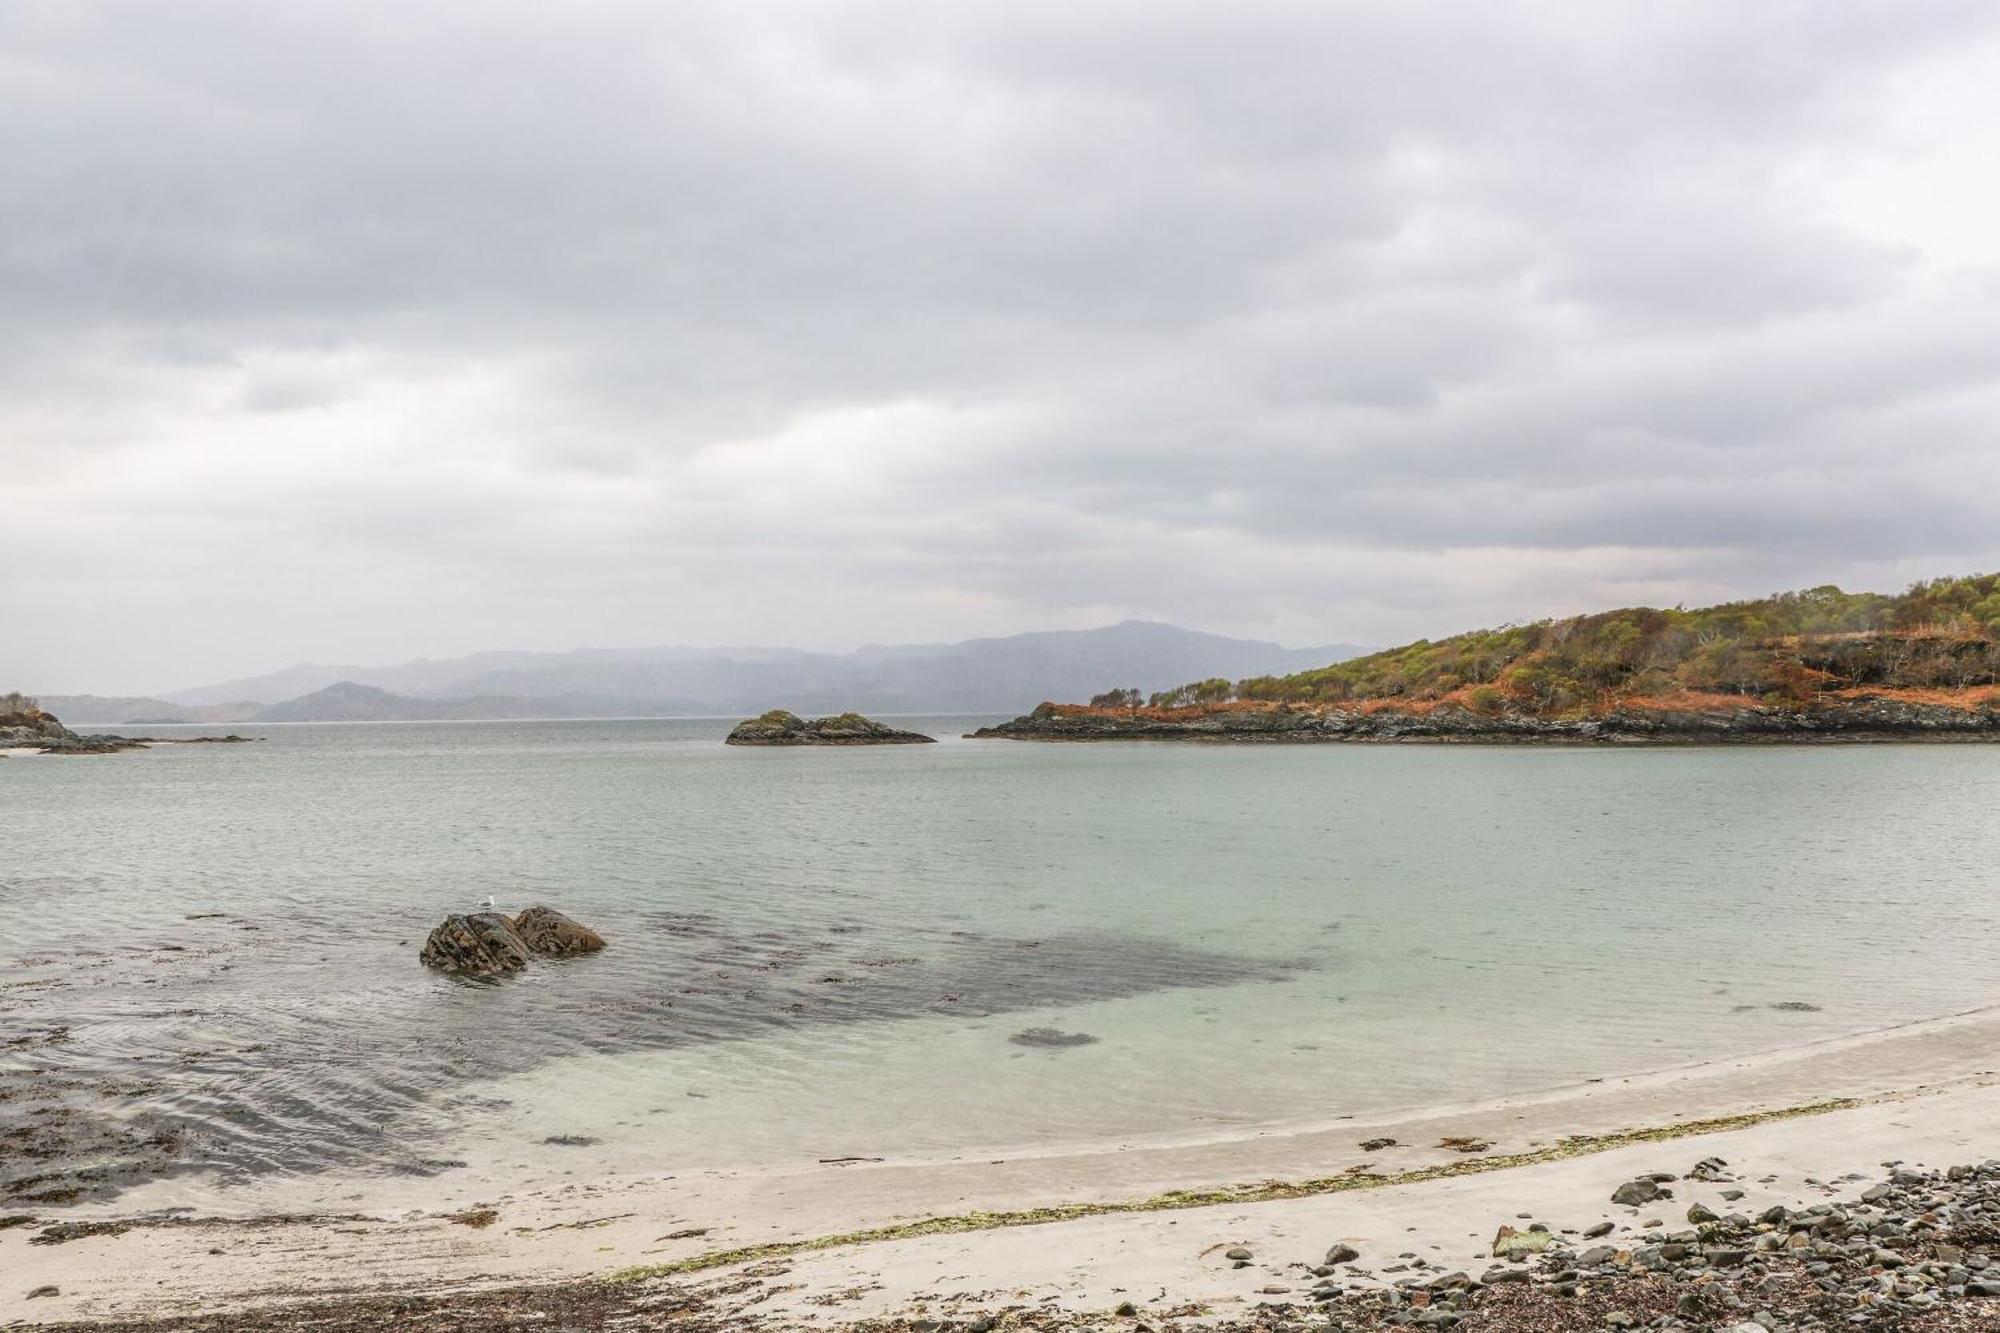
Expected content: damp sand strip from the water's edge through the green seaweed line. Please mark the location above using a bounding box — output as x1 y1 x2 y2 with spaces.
11 1009 2000 1323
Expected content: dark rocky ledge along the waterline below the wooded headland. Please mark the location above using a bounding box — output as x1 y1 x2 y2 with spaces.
970 697 2000 745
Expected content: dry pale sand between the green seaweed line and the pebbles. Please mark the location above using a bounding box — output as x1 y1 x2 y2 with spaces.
716 1089 2000 1323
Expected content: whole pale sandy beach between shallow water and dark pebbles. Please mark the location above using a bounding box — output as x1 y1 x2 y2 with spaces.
11 1011 2000 1327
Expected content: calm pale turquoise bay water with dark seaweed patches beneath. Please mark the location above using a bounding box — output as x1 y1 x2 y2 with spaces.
0 719 2000 1207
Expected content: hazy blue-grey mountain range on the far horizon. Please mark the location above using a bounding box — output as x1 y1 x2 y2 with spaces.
42 620 1368 727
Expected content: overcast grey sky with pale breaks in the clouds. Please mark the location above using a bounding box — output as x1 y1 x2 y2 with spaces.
0 0 2000 693
